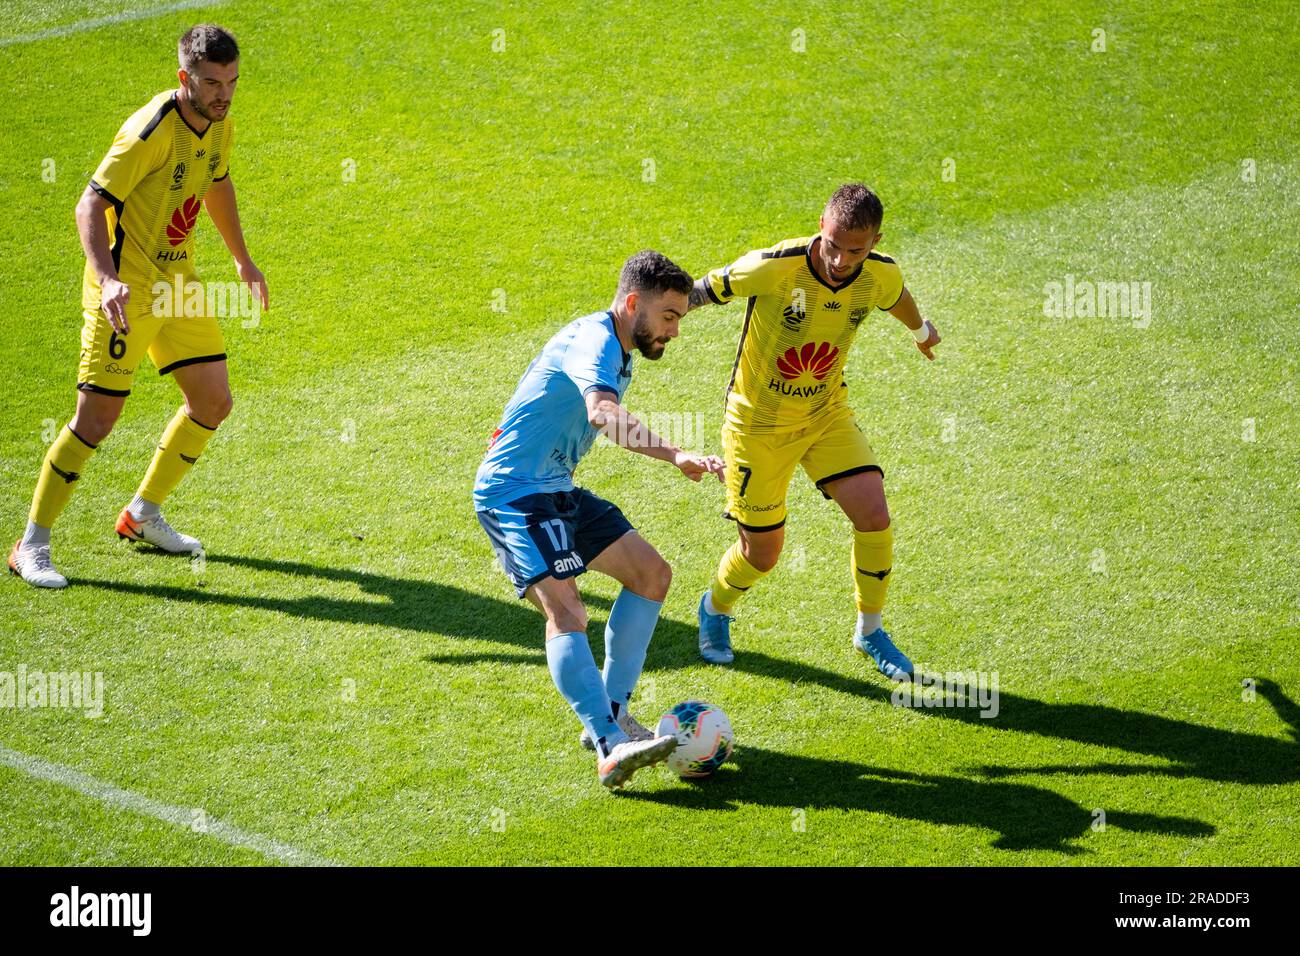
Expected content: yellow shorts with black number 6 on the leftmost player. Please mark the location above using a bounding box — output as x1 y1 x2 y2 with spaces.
77 295 226 395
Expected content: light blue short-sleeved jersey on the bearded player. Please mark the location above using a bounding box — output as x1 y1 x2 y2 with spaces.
475 312 632 511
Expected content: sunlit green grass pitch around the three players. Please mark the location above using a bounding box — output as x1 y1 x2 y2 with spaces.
0 0 1300 865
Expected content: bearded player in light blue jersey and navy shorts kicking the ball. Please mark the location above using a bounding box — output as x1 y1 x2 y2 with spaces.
475 250 723 788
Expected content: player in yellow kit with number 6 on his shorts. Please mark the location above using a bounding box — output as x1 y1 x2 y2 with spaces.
9 25 269 588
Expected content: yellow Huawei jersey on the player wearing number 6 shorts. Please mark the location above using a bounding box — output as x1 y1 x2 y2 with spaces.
82 90 234 312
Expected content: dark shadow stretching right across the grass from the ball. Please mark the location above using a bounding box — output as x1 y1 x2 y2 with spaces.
620 747 1216 855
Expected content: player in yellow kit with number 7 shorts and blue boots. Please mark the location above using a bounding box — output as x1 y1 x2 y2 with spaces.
690 183 939 680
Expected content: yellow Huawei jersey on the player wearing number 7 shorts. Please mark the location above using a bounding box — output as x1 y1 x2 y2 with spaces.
705 235 902 434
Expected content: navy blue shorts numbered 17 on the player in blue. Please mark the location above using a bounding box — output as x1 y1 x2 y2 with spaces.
476 488 633 597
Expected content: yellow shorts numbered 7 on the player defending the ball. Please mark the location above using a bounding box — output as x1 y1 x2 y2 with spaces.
723 406 884 531
